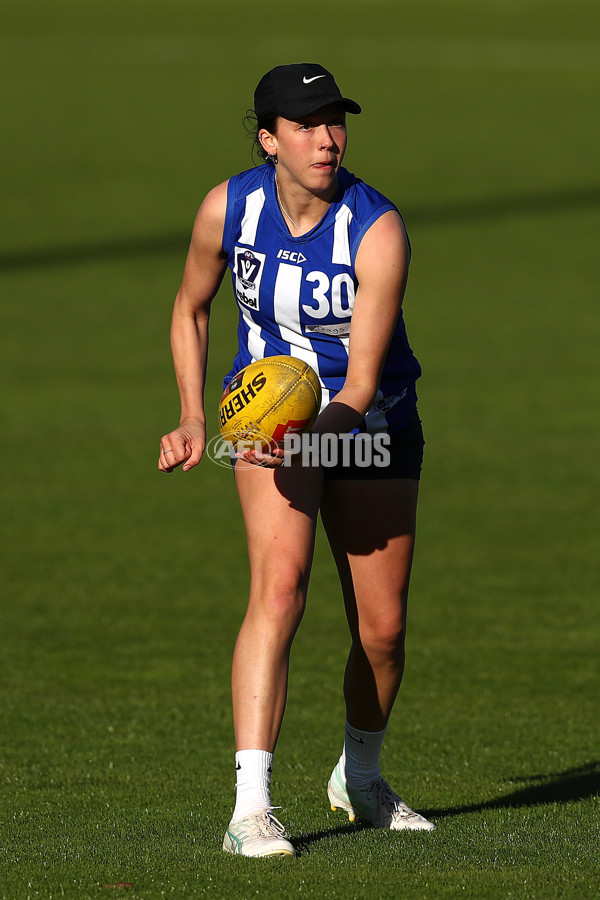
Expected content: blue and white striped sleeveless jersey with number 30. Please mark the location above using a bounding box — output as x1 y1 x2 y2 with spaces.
223 165 421 432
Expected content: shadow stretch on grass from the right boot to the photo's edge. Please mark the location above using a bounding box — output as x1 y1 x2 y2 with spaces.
419 760 600 819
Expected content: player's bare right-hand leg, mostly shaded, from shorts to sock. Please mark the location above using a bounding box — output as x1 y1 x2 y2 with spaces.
322 479 418 732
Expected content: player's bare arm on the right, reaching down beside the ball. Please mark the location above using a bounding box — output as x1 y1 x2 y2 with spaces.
312 210 410 434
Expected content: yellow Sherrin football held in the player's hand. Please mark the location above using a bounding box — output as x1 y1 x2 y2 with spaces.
219 356 321 448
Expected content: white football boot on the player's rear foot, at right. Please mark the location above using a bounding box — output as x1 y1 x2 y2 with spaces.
327 763 435 831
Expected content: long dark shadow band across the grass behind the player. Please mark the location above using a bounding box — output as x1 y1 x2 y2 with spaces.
0 185 600 271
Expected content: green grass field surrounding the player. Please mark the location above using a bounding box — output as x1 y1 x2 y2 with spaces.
0 0 600 900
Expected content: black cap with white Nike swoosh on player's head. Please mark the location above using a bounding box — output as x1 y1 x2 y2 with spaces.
254 63 361 119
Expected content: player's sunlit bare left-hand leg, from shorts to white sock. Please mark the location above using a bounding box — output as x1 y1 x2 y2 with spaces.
232 460 322 752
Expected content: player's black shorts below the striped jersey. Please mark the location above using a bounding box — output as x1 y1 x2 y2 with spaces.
321 410 425 481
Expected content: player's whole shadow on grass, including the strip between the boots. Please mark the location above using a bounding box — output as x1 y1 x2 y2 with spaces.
294 761 600 856
